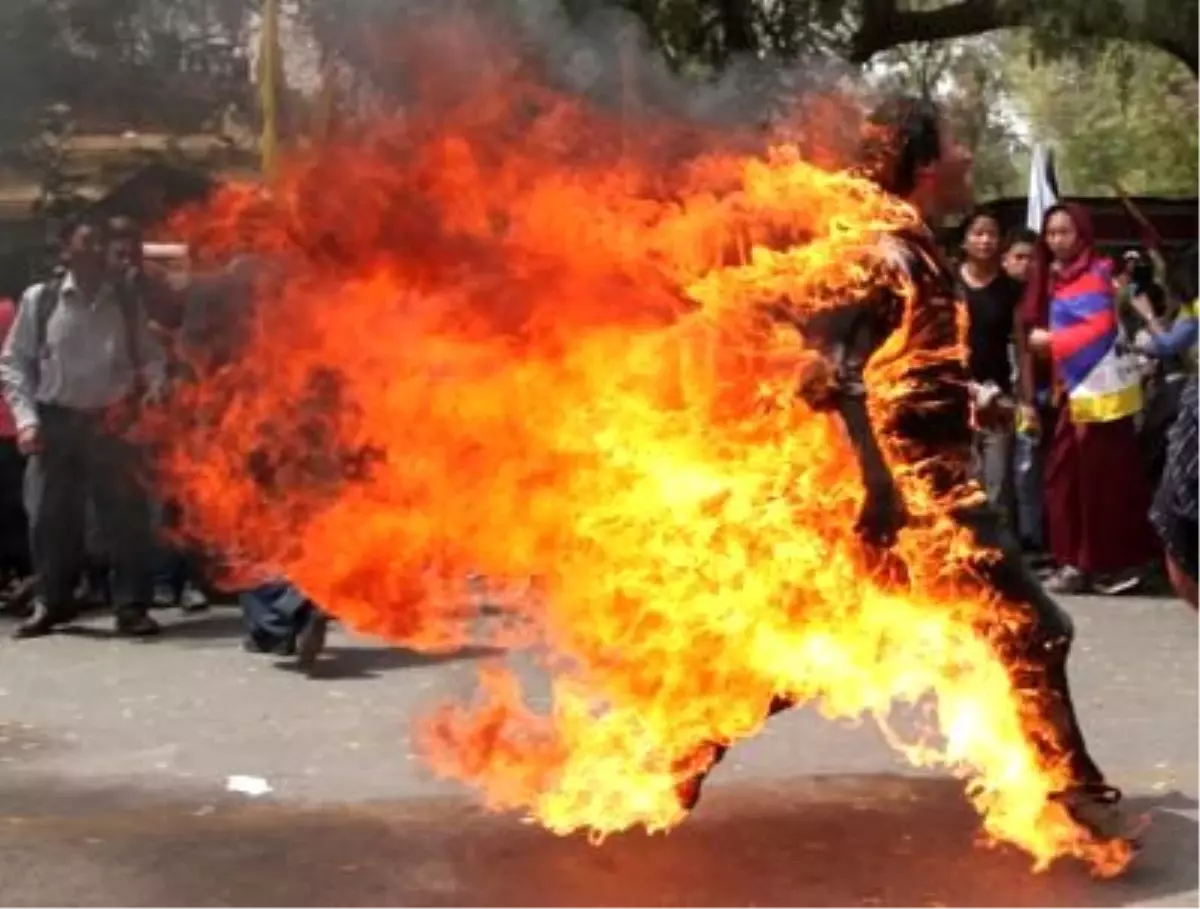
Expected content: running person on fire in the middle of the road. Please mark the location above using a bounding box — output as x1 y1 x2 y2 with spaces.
678 98 1135 845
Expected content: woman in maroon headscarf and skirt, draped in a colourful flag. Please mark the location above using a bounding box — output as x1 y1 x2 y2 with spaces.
1020 205 1157 594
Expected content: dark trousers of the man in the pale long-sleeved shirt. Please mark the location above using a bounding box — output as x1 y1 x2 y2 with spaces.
25 405 154 609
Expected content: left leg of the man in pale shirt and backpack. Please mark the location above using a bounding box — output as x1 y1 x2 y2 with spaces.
17 408 86 637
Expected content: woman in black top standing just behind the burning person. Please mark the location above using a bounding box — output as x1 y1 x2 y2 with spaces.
958 209 1021 528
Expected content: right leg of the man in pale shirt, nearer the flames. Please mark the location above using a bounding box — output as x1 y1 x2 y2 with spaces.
88 422 158 636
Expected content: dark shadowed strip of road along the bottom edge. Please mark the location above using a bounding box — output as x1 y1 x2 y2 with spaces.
0 776 1200 909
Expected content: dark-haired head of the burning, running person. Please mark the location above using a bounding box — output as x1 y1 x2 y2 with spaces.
865 96 973 218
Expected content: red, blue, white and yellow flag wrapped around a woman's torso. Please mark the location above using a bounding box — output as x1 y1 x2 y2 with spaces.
1050 260 1142 423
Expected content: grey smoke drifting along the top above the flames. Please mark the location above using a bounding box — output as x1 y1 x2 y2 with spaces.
317 0 862 139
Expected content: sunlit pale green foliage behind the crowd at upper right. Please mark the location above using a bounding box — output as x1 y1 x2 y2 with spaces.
1007 43 1200 194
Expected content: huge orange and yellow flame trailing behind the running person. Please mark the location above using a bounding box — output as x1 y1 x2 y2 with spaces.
157 51 1128 872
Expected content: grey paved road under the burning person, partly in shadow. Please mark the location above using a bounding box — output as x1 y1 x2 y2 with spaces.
0 600 1200 909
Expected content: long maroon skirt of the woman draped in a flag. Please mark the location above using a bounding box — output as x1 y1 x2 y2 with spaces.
1045 407 1159 574
